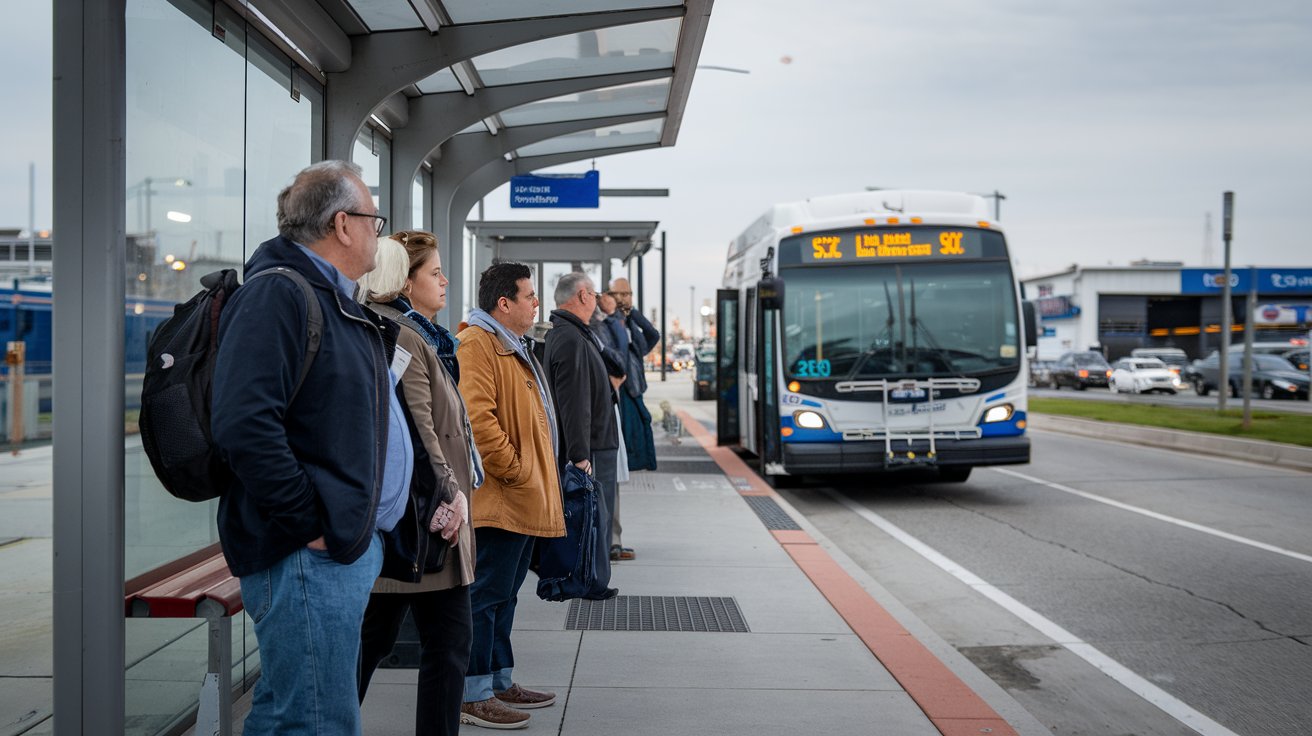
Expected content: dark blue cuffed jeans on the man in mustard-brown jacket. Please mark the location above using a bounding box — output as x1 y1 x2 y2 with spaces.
464 526 534 703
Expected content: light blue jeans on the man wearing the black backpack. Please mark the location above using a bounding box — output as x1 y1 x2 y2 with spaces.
241 534 383 736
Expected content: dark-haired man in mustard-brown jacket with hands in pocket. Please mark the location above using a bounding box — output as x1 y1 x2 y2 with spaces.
457 262 565 728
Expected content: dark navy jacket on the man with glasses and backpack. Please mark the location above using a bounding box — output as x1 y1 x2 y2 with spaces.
210 237 398 576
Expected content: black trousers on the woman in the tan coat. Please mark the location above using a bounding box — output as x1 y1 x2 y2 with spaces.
359 585 472 736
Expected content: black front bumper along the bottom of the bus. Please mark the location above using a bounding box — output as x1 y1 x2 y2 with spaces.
782 436 1030 475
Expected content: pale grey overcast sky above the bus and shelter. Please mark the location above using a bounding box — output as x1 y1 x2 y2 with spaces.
0 0 1312 326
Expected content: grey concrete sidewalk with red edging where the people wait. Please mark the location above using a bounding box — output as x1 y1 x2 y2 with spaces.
363 380 1048 736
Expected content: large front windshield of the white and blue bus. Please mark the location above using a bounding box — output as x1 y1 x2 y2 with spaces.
781 261 1021 380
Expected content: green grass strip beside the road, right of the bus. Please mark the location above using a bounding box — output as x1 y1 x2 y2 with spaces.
1030 396 1312 447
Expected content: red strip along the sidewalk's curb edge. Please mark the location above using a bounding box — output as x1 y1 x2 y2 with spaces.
678 411 1015 736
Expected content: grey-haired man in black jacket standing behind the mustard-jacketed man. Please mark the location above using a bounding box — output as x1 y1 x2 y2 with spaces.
544 272 619 598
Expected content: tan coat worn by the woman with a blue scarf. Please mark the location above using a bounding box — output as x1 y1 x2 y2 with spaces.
369 304 474 593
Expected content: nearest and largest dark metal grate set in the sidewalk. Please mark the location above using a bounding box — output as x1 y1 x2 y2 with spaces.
565 596 750 634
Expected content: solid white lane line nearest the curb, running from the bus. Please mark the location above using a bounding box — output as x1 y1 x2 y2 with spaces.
820 488 1239 736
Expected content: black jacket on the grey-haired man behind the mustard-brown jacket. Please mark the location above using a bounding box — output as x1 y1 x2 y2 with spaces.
543 310 619 464
